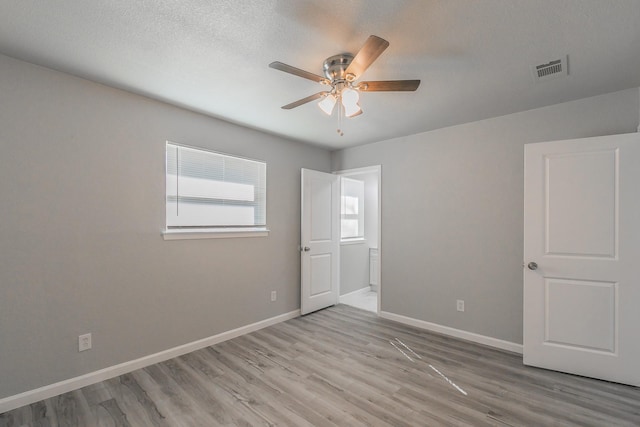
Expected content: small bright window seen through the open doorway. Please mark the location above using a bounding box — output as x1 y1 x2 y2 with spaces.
340 177 364 240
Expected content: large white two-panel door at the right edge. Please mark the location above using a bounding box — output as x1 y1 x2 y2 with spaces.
524 134 640 386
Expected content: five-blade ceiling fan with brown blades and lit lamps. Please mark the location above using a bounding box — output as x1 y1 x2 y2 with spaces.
269 36 420 127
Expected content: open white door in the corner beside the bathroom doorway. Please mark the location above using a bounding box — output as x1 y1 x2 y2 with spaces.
300 169 340 314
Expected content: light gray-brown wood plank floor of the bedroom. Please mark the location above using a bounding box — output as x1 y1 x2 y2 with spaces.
0 305 640 427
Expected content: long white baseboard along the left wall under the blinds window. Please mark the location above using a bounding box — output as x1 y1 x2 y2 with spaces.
0 310 300 414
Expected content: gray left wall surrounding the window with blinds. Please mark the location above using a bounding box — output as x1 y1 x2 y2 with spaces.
0 56 330 398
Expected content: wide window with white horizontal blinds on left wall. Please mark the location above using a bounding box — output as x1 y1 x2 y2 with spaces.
166 142 267 237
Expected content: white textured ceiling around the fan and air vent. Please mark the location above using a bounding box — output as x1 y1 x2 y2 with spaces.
0 0 640 149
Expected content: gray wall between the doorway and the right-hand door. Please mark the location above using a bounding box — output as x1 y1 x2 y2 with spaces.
332 89 639 343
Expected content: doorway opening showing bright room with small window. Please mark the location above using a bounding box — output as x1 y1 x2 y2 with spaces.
334 165 382 313
